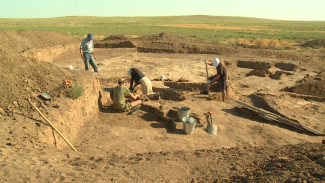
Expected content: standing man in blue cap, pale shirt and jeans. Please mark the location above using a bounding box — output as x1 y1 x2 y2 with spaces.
80 33 98 72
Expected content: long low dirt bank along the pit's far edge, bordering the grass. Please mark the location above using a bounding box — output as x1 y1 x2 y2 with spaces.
95 32 323 66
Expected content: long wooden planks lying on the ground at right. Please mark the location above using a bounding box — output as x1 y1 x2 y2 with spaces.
236 100 325 136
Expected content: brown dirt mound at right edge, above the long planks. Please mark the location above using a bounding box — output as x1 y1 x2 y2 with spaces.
284 72 325 97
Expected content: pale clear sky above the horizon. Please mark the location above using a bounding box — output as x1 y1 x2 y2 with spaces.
0 0 325 21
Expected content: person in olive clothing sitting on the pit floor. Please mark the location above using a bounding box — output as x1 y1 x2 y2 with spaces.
113 78 141 112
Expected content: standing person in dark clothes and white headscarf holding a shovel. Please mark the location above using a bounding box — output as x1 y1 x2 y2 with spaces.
201 58 227 101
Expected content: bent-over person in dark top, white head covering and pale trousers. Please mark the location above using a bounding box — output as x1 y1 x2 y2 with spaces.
128 68 152 95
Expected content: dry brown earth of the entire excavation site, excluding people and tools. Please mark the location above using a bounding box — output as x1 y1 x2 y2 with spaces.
0 31 325 182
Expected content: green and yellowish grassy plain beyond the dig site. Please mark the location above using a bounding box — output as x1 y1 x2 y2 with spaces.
0 15 325 47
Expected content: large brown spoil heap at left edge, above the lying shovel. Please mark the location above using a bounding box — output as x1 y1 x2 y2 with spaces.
0 31 79 114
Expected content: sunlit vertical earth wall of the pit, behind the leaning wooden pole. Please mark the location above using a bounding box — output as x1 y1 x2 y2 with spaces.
40 75 101 149
